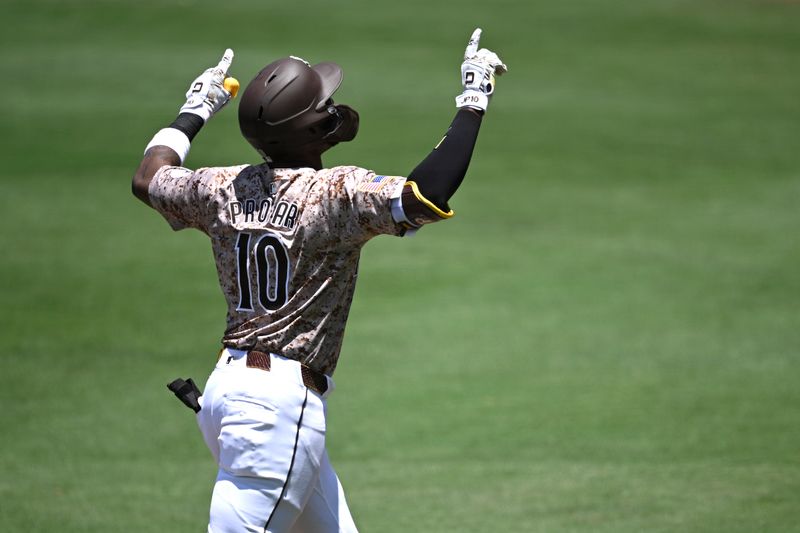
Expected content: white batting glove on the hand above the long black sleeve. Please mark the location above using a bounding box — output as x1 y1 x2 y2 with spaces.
456 28 508 111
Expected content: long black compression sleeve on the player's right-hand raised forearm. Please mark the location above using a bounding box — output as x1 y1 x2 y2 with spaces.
408 109 483 211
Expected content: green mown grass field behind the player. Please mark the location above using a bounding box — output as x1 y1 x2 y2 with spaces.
0 0 800 533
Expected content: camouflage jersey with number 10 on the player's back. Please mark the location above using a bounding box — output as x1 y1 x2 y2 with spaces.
149 165 410 375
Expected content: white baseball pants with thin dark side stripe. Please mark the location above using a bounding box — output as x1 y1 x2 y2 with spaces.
197 348 357 533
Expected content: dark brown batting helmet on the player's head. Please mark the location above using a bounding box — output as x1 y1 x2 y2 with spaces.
239 56 358 162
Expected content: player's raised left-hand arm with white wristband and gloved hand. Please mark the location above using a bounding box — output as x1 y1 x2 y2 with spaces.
131 48 239 205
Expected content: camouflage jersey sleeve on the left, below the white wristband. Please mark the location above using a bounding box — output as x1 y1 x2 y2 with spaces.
148 166 231 231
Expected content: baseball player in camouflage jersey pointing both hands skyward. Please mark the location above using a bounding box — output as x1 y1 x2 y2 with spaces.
133 29 507 533
